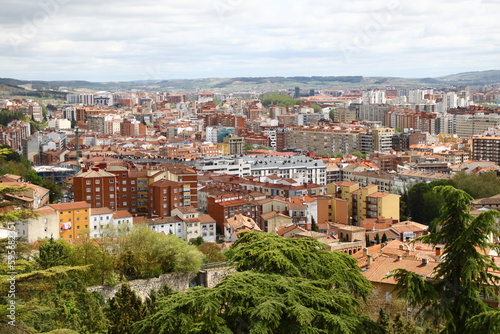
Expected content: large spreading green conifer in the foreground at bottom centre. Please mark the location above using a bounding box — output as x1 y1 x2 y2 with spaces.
134 233 382 333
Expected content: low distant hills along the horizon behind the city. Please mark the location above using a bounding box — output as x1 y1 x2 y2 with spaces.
0 70 500 91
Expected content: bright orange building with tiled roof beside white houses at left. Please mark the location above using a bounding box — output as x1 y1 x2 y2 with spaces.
49 202 90 242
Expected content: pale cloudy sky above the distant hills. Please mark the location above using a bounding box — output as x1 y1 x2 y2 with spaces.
0 0 500 82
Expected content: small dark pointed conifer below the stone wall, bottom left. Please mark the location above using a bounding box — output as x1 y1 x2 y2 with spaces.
105 283 146 334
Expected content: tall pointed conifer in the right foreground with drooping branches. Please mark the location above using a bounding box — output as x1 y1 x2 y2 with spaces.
390 186 500 334
